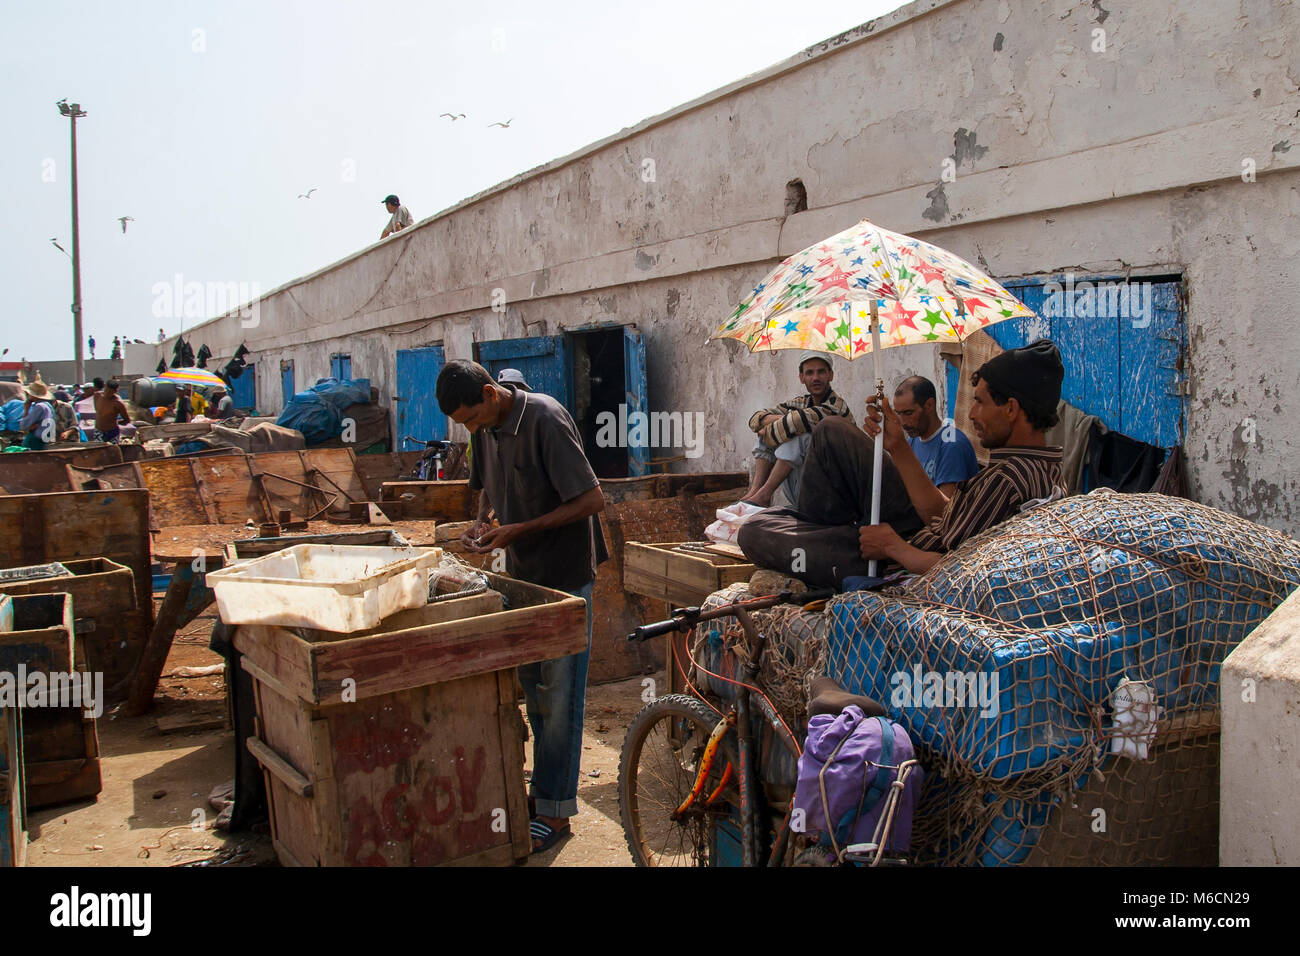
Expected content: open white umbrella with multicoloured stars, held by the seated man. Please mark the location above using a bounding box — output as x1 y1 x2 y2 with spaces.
709 220 1035 575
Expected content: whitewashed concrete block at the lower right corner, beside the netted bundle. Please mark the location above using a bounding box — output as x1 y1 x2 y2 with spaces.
1219 591 1300 866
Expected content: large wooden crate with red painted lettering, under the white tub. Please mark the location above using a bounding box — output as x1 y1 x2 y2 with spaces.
234 575 586 866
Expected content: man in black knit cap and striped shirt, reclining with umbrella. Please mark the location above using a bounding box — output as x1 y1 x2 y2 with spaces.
738 339 1065 585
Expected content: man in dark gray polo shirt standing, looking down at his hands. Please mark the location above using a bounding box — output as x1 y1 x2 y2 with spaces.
436 360 610 852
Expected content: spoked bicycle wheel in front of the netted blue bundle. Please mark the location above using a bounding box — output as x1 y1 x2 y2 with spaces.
619 693 740 866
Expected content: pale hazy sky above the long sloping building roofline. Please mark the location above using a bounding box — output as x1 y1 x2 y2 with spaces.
0 0 901 362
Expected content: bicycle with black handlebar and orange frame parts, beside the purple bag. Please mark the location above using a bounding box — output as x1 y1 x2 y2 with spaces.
619 591 914 866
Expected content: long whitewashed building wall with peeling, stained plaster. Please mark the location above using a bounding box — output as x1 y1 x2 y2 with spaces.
175 0 1300 532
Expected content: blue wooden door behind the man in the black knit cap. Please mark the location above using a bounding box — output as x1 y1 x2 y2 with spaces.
988 277 1183 449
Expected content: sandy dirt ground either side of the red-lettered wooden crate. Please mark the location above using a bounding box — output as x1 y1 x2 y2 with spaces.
27 608 663 866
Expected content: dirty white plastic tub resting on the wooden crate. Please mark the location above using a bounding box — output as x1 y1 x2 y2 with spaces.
208 545 442 633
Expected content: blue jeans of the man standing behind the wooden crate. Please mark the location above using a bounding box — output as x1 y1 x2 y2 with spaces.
519 581 594 817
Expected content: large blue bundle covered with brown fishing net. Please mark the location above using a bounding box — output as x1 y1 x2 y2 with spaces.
826 490 1300 865
